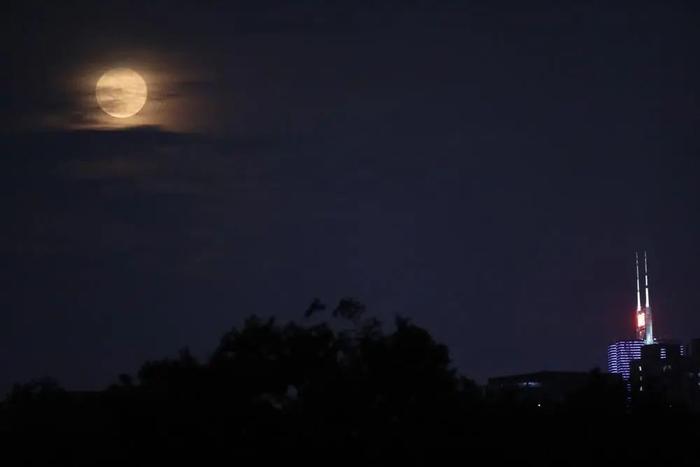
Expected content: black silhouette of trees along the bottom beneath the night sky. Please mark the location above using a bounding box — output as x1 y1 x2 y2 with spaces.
0 299 700 467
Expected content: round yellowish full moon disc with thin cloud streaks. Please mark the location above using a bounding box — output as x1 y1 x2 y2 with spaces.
95 68 148 118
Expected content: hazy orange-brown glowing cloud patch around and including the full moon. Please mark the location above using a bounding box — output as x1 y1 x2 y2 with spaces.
28 49 219 133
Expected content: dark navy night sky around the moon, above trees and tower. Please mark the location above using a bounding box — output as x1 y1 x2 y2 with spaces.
0 0 700 390
